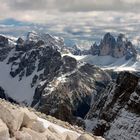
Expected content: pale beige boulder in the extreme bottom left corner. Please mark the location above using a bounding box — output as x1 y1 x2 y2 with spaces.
0 119 9 140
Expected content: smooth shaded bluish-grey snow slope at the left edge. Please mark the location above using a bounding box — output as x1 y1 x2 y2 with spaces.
0 49 41 105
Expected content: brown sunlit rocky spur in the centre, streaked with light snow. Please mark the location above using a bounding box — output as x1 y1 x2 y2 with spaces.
34 61 110 123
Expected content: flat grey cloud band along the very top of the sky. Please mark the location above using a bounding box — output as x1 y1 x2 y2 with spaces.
1 0 140 11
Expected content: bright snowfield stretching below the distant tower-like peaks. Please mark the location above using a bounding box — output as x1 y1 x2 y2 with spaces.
62 53 140 71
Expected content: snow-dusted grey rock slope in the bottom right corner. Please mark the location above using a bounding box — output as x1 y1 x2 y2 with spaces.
105 109 140 140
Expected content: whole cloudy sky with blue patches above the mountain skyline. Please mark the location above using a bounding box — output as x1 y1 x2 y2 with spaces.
0 0 140 45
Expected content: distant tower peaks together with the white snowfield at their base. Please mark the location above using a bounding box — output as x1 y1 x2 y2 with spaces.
63 33 140 71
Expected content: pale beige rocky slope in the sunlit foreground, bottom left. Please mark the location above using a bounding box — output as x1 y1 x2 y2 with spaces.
0 99 104 140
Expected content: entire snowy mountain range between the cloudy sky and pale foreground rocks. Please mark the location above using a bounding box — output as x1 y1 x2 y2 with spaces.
0 32 140 140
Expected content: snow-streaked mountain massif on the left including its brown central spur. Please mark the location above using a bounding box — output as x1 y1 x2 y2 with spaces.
0 32 111 123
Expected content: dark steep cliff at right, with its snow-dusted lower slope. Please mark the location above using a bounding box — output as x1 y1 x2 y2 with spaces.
86 72 140 140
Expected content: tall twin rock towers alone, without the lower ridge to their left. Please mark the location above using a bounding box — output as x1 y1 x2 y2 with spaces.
96 33 137 60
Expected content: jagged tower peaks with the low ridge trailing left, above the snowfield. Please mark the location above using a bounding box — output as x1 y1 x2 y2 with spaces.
71 33 137 60
